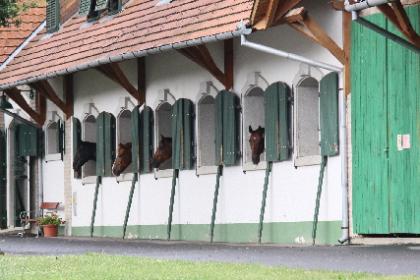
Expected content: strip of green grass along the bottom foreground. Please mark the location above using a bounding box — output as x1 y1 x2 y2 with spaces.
0 254 419 280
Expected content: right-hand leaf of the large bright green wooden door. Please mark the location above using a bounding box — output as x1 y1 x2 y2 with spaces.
387 5 420 233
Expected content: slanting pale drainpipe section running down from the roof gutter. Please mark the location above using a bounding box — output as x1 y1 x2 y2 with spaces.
241 34 342 72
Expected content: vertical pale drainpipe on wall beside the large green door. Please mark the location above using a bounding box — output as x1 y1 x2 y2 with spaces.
338 90 349 244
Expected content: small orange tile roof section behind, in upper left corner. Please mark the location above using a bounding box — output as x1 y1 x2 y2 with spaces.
0 1 45 65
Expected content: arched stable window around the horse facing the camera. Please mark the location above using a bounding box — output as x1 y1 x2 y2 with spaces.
242 87 267 171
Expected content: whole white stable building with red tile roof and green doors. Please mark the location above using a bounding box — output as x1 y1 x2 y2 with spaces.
0 0 420 244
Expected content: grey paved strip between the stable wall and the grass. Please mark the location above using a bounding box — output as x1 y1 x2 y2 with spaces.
0 236 420 275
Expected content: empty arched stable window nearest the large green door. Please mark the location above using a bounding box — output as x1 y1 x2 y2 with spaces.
294 77 321 166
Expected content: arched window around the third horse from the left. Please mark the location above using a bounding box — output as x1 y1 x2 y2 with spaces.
155 102 172 174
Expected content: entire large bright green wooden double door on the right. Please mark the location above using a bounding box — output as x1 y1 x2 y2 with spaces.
351 6 420 234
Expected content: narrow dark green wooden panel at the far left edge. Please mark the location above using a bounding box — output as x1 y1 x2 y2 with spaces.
0 129 7 229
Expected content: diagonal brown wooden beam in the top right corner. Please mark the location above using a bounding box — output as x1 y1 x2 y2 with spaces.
378 1 420 48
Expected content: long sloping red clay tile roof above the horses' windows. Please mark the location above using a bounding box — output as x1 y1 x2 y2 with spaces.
0 0 254 87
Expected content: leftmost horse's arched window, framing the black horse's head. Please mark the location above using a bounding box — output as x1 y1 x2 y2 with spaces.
82 115 96 180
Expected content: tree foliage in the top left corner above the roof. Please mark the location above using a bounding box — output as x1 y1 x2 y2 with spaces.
0 0 36 27
